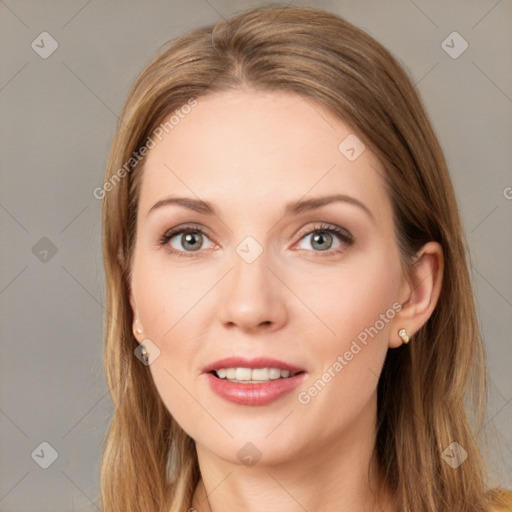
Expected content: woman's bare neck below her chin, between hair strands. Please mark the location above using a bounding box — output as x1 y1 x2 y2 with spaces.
191 392 397 512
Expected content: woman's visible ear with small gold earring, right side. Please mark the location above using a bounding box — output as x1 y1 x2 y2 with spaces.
389 242 444 348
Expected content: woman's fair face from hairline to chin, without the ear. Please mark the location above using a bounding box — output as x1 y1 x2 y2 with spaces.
130 91 408 464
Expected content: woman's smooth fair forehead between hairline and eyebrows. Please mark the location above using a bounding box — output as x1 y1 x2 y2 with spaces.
140 91 389 220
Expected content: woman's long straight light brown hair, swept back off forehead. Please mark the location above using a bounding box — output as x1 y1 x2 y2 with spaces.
98 6 505 512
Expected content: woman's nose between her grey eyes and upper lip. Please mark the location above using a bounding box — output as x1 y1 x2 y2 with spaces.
218 243 289 332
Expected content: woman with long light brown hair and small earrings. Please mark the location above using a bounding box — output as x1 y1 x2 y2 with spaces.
101 7 511 512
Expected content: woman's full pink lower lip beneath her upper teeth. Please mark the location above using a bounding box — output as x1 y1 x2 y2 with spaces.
205 372 306 405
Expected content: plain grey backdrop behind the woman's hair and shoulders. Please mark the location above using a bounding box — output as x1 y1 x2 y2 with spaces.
0 0 512 512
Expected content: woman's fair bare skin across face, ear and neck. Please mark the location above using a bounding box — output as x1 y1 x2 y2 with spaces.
130 90 443 512
